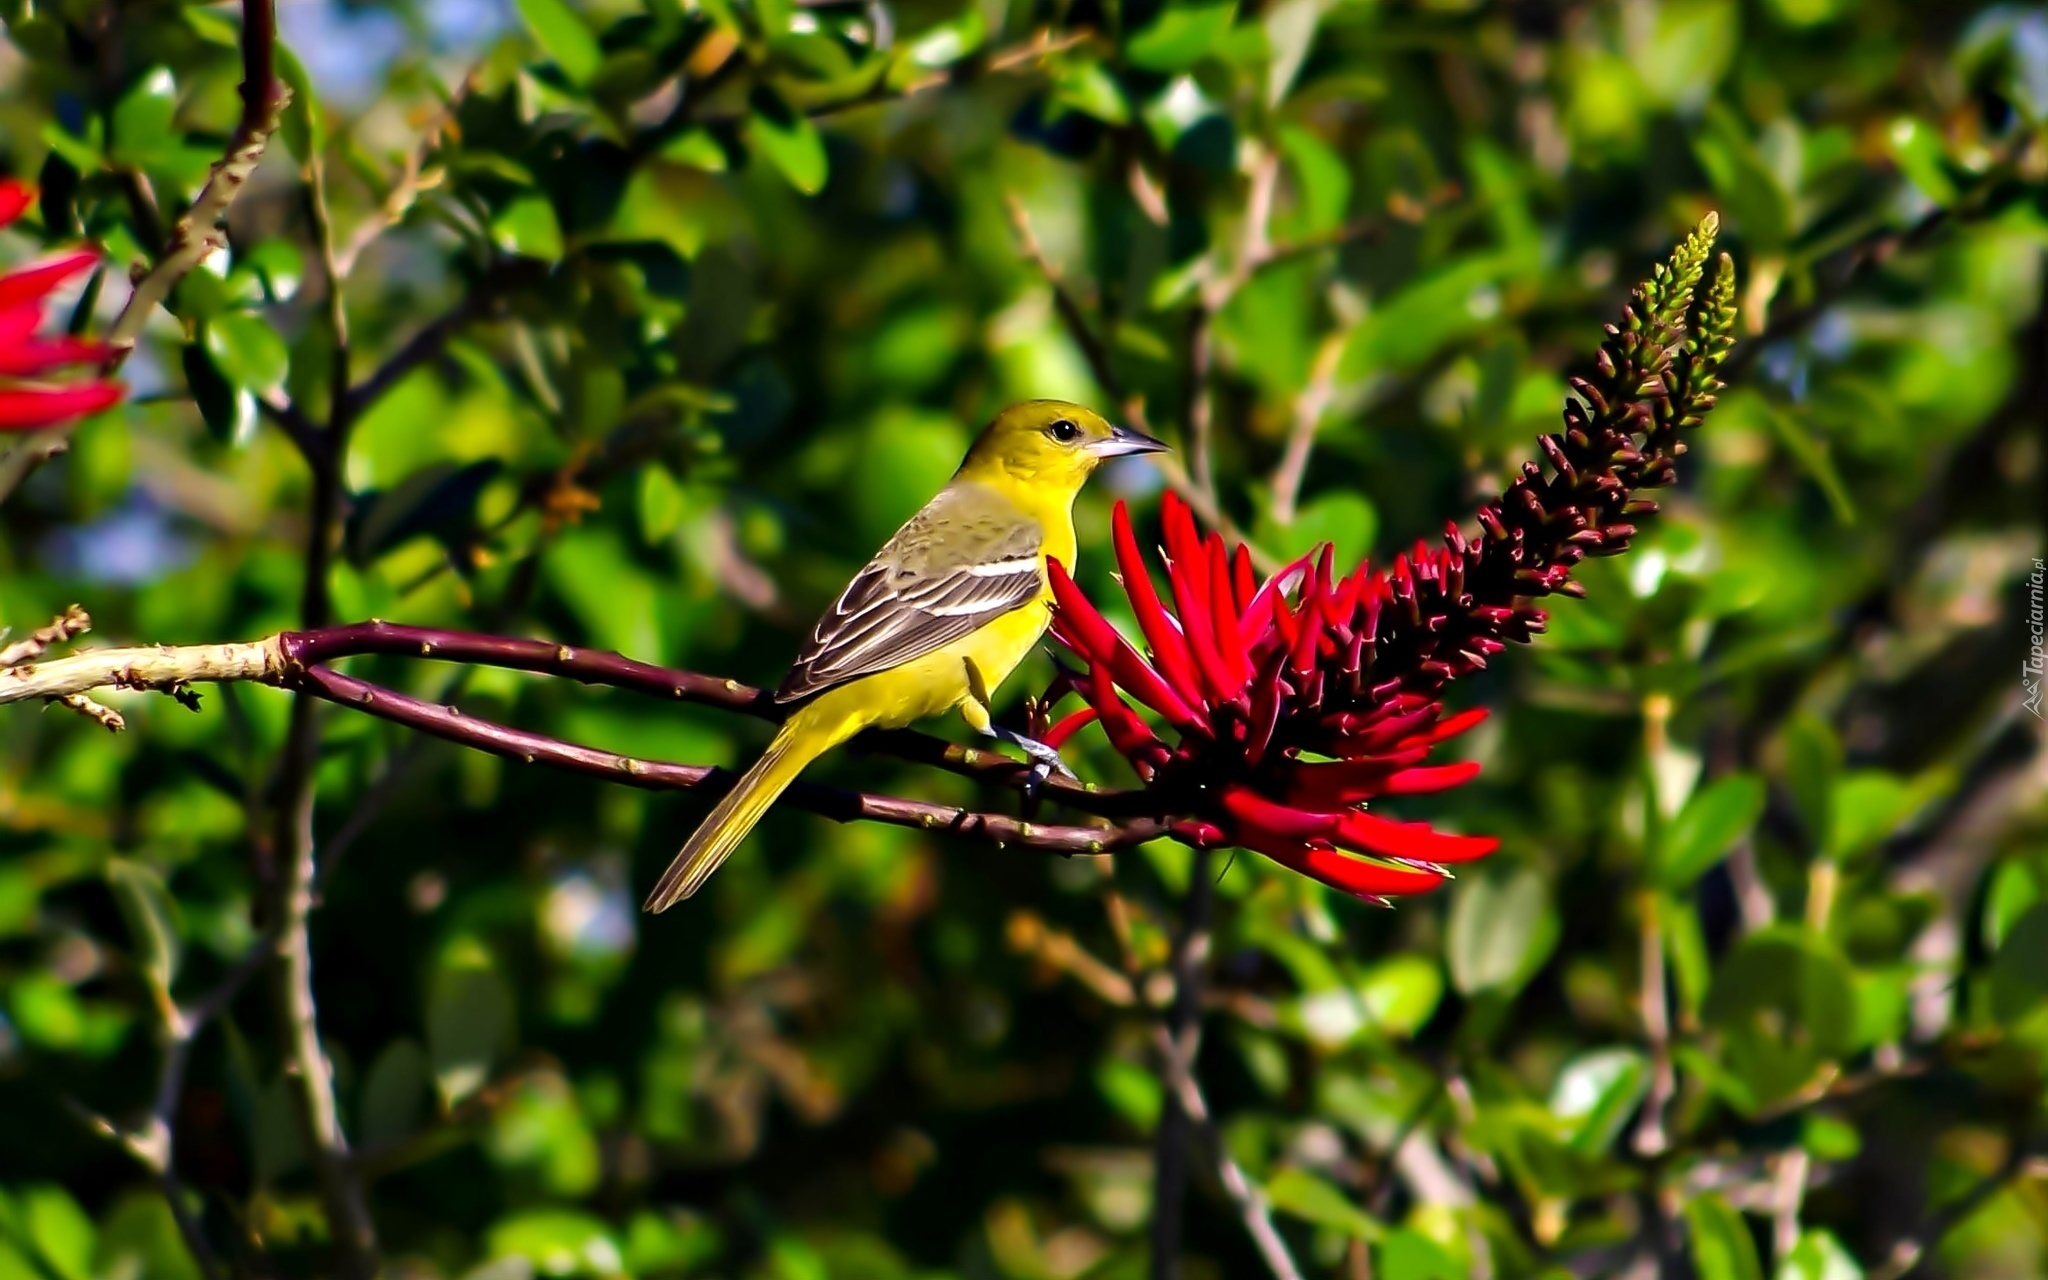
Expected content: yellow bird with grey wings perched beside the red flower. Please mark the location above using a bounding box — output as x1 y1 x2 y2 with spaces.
647 399 1165 911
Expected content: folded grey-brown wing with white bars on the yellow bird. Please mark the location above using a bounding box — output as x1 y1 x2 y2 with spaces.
776 487 1044 702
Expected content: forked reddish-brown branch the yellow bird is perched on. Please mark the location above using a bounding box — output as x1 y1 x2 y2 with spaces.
0 621 1174 854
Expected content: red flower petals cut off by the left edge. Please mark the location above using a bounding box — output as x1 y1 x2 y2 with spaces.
0 180 125 430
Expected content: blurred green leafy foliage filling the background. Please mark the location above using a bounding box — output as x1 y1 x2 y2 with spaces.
0 0 2048 1280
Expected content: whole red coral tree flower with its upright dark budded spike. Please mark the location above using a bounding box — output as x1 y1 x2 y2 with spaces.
1047 217 1735 901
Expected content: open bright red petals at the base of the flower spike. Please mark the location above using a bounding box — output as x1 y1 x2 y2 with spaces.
1047 494 1501 901
